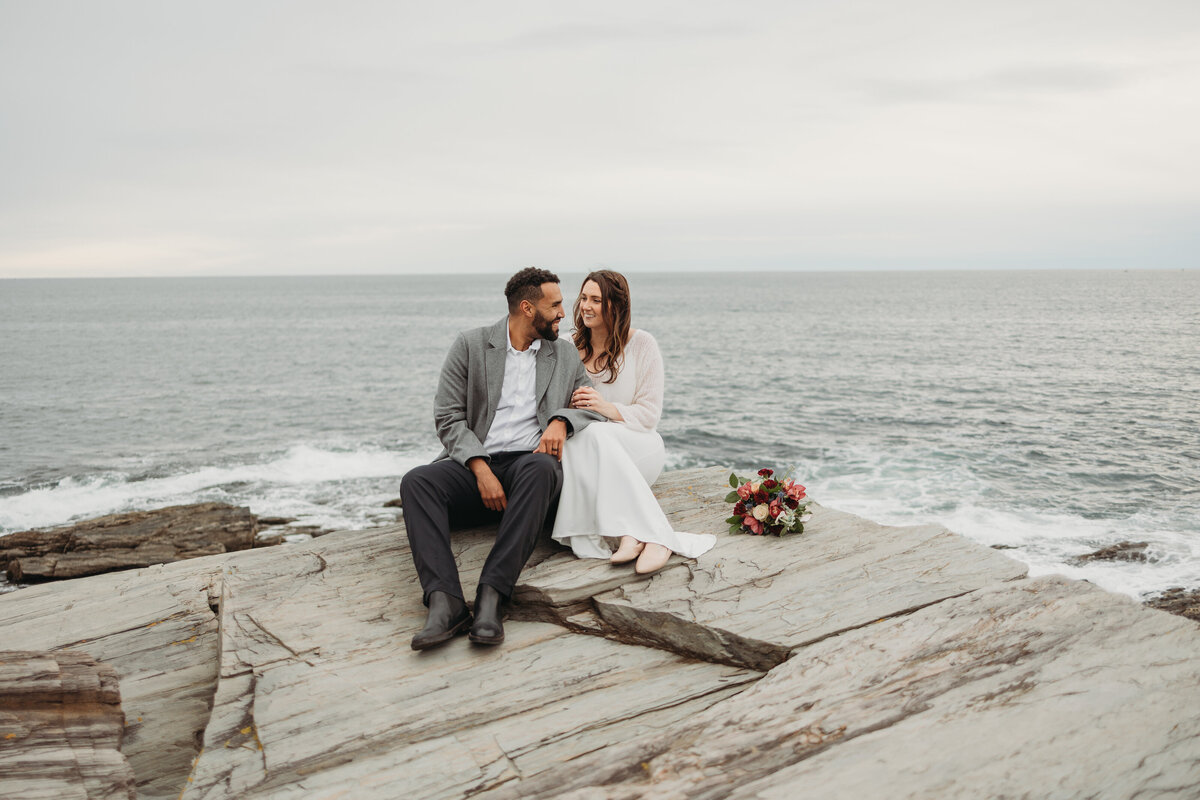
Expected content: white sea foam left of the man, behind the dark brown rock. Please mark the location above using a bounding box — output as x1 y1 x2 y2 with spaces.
0 444 434 533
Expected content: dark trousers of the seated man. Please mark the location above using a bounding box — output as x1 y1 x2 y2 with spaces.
400 452 563 606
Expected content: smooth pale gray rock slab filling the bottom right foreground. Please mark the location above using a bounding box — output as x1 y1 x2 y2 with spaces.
494 576 1200 800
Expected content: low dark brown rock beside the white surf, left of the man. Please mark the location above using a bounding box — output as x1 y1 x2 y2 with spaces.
0 503 258 582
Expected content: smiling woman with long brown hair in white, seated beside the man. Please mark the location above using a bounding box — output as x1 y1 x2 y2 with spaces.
552 270 716 575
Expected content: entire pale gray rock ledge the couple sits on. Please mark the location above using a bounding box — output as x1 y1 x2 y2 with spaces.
0 469 1200 800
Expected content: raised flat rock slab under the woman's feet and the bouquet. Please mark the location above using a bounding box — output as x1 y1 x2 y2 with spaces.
516 470 1026 670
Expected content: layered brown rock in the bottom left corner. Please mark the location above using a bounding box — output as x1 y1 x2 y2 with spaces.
0 650 136 800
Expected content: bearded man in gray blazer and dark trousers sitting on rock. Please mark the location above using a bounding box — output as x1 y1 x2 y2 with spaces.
400 267 604 650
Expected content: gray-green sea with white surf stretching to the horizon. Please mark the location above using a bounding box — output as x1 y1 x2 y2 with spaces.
0 271 1200 596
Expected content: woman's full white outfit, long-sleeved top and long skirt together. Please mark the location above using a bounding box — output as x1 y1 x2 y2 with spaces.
552 330 716 559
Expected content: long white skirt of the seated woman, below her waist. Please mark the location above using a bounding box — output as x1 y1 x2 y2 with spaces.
552 422 716 559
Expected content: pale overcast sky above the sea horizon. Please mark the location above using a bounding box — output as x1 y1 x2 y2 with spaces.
0 0 1200 277
